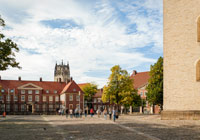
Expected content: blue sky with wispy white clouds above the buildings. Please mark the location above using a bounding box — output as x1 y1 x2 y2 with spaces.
0 0 163 87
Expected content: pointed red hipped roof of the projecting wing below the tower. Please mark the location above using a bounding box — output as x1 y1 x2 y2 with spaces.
61 80 83 94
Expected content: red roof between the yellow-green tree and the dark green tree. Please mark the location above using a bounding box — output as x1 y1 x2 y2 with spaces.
131 71 150 89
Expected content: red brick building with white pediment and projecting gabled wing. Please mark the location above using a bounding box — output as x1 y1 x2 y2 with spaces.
0 77 84 114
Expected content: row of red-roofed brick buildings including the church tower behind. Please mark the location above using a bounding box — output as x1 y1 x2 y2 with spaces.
0 62 159 114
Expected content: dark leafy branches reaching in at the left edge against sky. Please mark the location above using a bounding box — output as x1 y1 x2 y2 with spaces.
0 16 21 71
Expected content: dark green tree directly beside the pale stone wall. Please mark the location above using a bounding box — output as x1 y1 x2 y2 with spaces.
146 57 163 107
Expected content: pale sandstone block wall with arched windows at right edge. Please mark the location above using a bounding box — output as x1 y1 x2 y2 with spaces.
162 0 200 119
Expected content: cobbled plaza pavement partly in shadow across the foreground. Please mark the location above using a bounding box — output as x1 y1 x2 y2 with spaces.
0 115 200 140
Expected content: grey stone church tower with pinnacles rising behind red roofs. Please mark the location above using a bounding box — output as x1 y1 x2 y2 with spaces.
54 61 70 82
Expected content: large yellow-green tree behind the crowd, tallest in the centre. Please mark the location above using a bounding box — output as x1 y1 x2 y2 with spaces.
102 65 136 106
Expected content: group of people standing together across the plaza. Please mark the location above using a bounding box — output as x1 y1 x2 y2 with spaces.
57 108 119 121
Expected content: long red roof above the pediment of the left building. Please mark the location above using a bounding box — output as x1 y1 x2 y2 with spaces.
0 80 66 93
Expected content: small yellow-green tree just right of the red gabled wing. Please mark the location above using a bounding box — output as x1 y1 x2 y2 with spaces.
82 83 97 107
